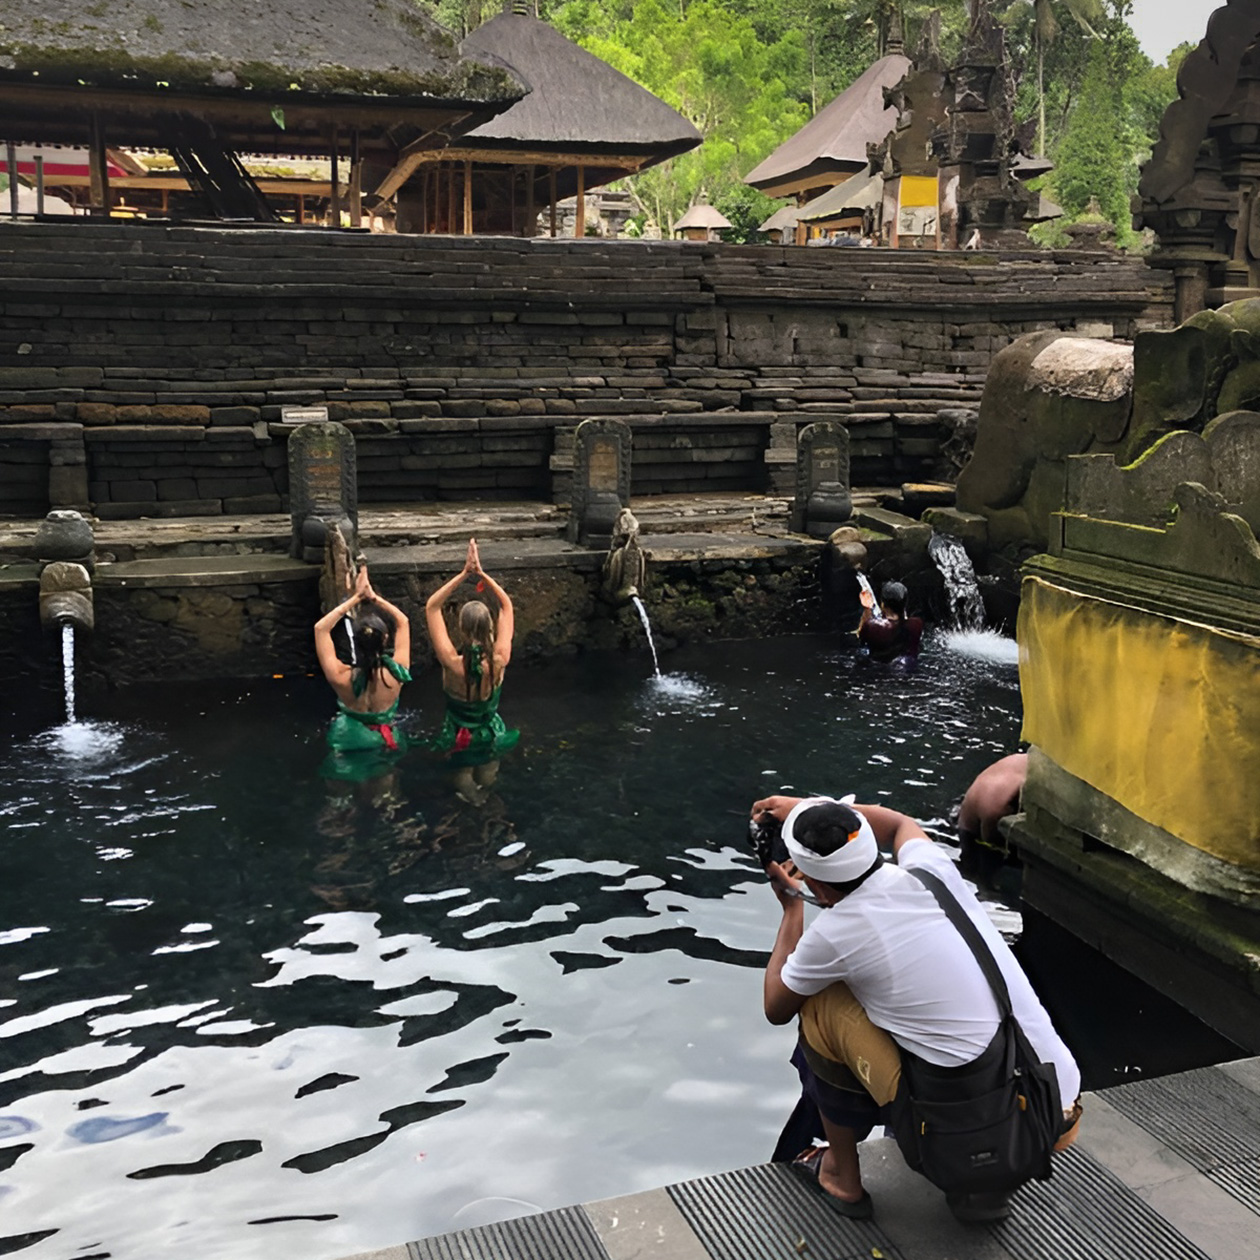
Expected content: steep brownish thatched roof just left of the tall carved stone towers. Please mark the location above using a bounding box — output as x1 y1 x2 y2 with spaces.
743 52 911 205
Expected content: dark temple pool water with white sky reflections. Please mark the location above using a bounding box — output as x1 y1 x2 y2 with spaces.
0 639 1227 1260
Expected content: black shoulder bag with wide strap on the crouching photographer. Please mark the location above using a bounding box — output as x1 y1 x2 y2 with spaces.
892 867 1063 1193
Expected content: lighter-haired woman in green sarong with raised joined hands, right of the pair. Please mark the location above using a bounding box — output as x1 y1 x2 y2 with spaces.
425 538 520 804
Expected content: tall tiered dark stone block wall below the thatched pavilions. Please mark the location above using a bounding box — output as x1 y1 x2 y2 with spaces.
0 222 1171 517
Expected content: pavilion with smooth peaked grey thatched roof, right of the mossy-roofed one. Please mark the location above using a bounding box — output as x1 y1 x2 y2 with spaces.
403 13 701 236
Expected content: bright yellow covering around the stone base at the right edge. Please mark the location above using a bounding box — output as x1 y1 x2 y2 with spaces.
1018 577 1260 871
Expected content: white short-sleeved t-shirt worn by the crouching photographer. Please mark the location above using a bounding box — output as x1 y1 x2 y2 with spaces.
782 839 1081 1108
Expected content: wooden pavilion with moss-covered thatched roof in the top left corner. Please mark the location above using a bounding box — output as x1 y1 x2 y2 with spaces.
0 0 528 223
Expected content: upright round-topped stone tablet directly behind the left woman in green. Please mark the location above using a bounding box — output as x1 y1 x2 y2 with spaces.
289 422 359 564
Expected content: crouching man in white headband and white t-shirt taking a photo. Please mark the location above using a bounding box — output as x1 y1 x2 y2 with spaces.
750 796 1081 1221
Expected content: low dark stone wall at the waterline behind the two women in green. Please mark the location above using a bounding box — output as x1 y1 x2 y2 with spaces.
0 549 823 694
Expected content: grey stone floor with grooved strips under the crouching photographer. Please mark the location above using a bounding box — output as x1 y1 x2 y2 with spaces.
337 1058 1260 1260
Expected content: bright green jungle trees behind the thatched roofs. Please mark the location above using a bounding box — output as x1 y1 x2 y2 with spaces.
416 0 1191 246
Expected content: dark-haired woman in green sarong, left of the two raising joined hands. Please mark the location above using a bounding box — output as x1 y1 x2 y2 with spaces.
315 564 411 777
